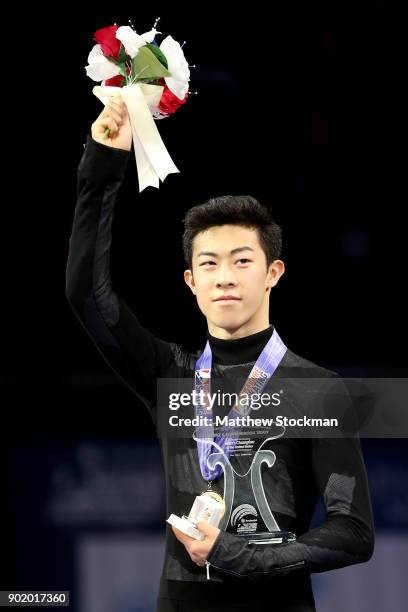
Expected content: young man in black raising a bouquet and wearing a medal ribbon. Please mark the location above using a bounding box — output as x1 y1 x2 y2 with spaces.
67 100 373 612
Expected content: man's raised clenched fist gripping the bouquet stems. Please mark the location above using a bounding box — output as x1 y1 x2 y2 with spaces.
91 95 132 151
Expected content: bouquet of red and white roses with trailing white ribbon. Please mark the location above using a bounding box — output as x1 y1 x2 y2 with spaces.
86 19 190 191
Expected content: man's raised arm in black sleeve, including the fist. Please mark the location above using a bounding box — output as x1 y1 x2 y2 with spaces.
66 95 176 416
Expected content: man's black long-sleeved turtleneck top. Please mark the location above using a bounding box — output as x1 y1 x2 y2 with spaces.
66 137 373 609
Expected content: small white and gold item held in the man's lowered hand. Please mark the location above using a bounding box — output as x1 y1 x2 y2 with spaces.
167 490 225 540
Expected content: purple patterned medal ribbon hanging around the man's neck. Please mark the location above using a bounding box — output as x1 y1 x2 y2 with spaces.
194 329 287 481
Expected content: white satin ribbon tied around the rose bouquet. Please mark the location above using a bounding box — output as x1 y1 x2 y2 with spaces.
93 83 180 192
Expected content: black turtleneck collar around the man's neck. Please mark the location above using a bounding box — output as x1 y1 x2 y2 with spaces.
207 325 273 365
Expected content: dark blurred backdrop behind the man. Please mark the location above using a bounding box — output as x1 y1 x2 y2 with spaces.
0 2 408 612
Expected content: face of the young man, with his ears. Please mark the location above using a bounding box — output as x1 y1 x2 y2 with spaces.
184 225 284 335
